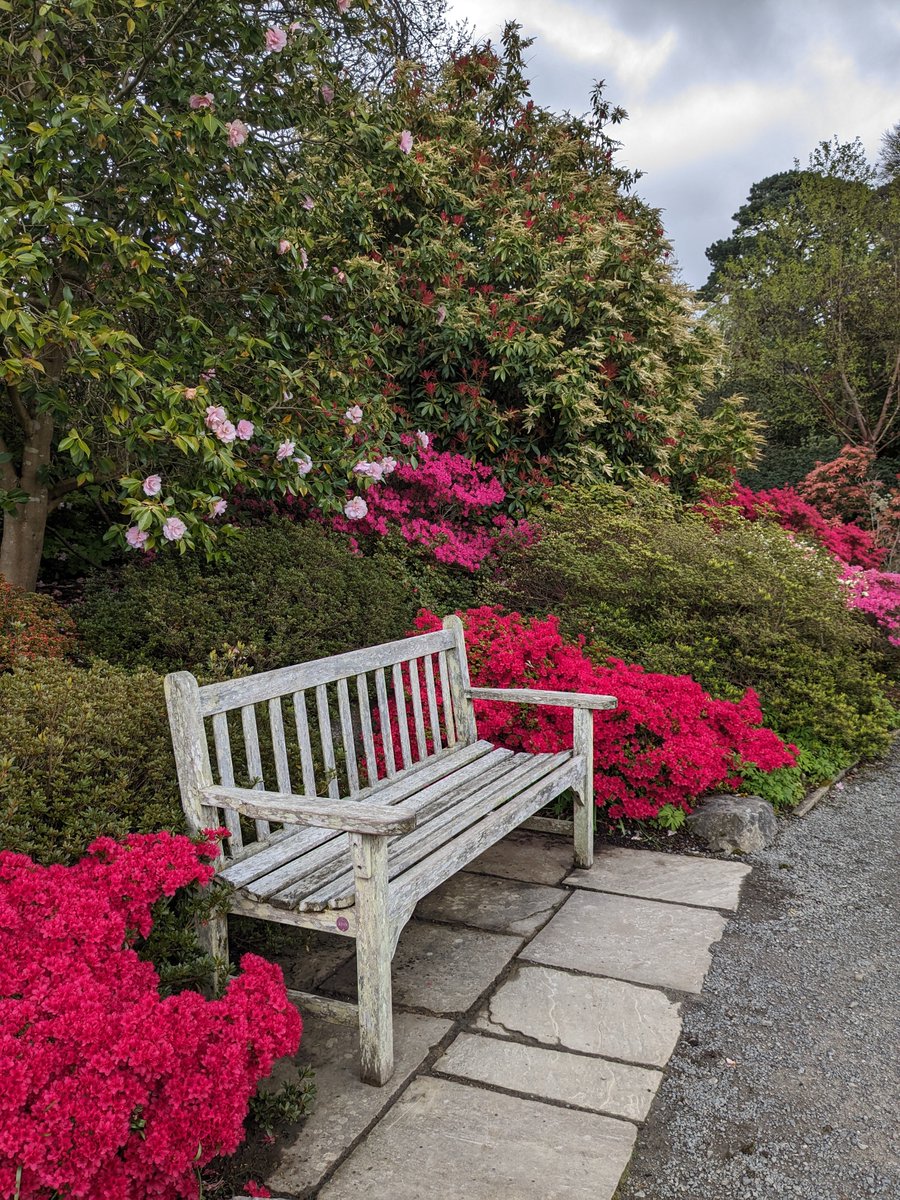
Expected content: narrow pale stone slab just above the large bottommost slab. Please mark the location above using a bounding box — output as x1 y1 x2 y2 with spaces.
434 1033 662 1121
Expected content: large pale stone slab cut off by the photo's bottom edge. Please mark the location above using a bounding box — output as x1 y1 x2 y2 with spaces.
319 1078 636 1200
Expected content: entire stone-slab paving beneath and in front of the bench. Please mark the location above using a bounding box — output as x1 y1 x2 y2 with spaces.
243 832 750 1200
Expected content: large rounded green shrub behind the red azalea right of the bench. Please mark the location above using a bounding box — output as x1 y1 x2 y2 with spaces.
490 488 898 803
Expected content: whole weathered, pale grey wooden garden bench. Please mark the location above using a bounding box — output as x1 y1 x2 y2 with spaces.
166 617 616 1084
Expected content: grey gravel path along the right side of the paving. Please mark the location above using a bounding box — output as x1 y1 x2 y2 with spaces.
617 743 900 1200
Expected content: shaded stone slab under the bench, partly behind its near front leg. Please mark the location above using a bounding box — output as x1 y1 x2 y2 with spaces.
323 920 522 1015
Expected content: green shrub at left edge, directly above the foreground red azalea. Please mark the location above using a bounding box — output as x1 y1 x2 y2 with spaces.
0 659 184 863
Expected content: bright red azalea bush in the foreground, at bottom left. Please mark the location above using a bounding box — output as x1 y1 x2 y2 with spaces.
0 833 301 1200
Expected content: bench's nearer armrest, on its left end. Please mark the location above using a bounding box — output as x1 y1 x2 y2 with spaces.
200 787 416 834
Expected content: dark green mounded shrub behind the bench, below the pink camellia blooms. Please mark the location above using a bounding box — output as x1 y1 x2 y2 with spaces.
76 520 420 678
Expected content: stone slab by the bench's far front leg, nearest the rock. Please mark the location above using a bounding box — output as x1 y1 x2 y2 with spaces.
565 846 750 911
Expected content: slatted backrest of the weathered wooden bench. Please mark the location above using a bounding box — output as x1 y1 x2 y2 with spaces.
166 617 476 856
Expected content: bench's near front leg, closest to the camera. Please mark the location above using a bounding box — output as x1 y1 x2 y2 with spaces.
350 834 394 1087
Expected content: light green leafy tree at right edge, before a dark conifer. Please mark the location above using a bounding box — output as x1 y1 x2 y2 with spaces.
714 142 900 452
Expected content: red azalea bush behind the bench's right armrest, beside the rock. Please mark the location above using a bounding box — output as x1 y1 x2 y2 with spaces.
415 607 794 820
